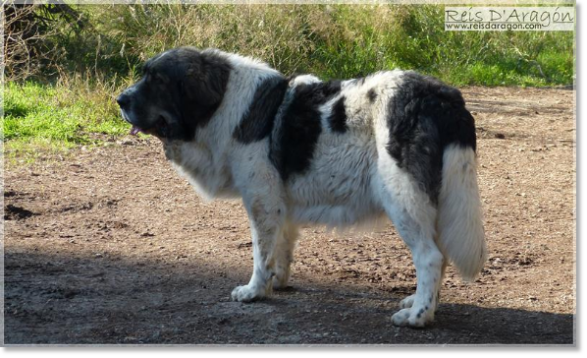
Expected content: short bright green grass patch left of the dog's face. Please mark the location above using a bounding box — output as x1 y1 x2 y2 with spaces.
4 82 128 157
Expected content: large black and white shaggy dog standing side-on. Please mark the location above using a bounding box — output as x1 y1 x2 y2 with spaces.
117 47 486 327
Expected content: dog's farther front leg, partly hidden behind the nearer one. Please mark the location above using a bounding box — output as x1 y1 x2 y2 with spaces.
273 223 299 289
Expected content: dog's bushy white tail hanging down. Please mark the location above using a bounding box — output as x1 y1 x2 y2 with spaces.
438 144 487 280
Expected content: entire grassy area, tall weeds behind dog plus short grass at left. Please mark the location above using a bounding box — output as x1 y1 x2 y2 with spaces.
4 5 574 159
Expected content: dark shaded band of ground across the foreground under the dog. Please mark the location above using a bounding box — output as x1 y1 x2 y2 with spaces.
5 249 574 344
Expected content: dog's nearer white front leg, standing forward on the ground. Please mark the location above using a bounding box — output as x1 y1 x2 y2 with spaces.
232 195 285 302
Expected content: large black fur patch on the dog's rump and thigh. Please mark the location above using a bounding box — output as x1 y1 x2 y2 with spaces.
387 72 476 204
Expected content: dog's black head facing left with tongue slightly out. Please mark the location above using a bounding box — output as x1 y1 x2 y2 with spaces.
116 47 230 141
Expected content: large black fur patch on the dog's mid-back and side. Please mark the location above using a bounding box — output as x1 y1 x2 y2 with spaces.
269 81 340 181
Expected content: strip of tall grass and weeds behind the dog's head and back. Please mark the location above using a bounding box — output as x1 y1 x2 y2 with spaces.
61 5 573 86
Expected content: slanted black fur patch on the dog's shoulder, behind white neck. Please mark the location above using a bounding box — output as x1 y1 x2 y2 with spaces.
233 76 288 143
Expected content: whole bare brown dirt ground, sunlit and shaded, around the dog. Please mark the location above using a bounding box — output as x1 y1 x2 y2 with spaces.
4 88 575 344
